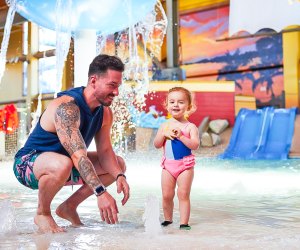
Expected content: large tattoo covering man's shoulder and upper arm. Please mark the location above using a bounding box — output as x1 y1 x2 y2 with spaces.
55 101 86 156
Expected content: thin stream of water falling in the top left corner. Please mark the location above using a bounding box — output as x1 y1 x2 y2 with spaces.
0 0 16 83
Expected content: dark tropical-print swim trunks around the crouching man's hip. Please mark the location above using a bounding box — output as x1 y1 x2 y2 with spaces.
13 150 40 189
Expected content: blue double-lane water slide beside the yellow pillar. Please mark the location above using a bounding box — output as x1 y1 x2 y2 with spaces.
219 107 297 159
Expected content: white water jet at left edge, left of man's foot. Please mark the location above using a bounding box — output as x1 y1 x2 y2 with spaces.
0 200 16 234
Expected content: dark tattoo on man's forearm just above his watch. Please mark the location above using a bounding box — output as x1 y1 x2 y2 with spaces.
78 156 101 189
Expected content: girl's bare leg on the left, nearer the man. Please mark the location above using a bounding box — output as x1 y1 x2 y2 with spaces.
161 169 176 222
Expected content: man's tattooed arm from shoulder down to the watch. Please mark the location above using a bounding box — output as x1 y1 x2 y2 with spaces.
55 101 101 190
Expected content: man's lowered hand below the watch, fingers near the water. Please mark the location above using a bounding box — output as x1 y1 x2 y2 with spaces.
97 191 119 224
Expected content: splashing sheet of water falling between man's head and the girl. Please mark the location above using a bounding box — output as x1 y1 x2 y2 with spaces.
97 1 167 153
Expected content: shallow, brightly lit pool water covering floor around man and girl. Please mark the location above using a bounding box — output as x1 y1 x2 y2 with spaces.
0 152 300 249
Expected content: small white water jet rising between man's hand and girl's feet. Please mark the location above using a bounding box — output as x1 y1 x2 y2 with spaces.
143 195 162 236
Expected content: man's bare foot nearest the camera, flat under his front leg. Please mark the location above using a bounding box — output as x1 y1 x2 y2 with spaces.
34 214 65 233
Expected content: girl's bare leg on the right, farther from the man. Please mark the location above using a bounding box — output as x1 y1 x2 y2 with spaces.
177 168 194 225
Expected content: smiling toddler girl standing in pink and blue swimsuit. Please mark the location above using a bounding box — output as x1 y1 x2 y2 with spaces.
154 87 200 230
